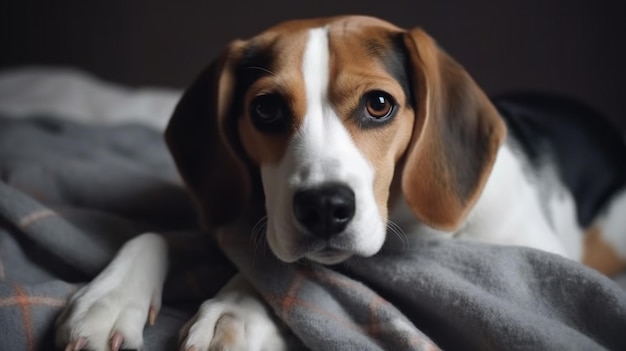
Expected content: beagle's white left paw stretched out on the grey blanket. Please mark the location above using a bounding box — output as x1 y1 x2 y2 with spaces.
56 234 167 351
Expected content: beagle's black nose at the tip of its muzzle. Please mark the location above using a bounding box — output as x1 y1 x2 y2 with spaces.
293 184 356 239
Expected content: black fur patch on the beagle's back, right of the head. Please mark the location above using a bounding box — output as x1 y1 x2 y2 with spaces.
493 93 626 227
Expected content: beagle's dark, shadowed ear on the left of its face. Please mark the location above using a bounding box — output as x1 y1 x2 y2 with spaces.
165 41 250 227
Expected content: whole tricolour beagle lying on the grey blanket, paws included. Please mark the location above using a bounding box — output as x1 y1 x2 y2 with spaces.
57 16 626 350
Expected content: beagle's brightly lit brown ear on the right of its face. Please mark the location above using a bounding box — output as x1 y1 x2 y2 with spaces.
402 29 506 230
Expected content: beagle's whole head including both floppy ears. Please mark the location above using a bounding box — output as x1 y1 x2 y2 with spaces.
166 17 505 264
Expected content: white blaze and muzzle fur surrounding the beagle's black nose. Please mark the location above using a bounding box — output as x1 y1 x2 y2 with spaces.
261 28 385 263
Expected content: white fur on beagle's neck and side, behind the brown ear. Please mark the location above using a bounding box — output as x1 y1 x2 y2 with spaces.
391 144 582 260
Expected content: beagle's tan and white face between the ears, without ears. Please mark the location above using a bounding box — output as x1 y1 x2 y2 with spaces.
237 17 414 263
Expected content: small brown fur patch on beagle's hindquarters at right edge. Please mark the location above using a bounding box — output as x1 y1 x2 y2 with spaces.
582 226 626 276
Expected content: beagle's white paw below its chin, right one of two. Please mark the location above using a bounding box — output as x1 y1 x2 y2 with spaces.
180 275 287 351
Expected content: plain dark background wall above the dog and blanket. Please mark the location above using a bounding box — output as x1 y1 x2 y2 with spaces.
0 0 626 130
